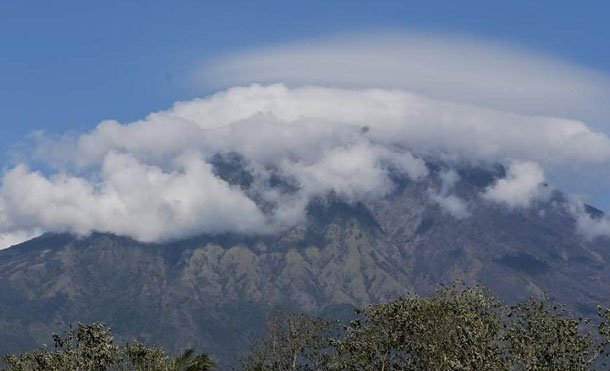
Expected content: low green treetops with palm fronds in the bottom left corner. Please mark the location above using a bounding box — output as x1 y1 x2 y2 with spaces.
4 323 214 371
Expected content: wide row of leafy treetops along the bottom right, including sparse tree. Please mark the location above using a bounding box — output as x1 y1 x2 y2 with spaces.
244 285 610 371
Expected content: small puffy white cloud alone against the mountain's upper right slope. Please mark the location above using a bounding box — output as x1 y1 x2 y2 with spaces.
482 161 550 208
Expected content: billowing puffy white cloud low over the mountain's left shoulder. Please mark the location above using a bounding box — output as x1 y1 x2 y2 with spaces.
0 152 266 241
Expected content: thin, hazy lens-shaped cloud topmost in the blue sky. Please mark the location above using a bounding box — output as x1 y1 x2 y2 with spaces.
199 31 610 122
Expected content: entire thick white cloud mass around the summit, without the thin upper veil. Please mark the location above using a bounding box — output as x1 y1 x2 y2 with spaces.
0 84 610 247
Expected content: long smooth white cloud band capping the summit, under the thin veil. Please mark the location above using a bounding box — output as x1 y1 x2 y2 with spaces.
34 84 610 166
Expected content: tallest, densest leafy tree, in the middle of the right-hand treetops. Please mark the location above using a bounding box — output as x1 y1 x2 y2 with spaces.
330 287 507 370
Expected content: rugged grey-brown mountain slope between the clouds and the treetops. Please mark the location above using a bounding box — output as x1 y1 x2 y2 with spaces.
0 163 610 366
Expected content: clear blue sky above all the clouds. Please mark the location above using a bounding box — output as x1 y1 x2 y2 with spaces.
0 0 610 163
